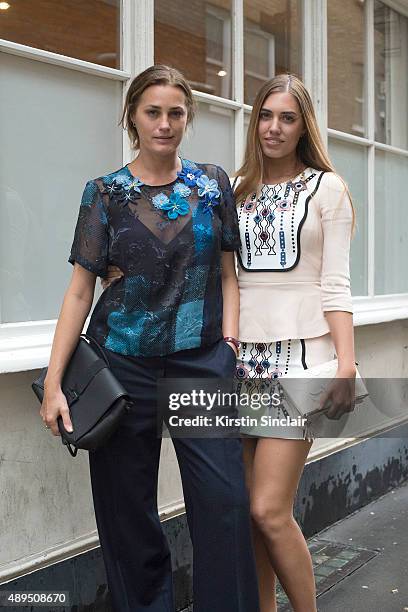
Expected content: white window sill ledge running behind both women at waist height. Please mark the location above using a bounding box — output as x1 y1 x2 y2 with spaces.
0 294 408 374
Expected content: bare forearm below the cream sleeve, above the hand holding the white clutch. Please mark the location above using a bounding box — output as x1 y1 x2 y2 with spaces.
324 310 356 376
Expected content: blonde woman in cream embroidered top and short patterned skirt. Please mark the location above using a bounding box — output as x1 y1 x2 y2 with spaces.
235 74 355 612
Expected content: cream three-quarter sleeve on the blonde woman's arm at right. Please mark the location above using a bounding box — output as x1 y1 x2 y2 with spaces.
318 172 353 313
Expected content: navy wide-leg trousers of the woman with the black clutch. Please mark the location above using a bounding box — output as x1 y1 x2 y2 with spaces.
89 340 259 612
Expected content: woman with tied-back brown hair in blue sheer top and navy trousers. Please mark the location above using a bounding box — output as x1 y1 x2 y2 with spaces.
41 65 259 612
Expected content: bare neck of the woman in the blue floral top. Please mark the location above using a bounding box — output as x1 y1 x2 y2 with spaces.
128 151 182 185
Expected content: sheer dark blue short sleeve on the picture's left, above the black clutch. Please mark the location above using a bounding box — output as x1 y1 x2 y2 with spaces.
68 181 108 277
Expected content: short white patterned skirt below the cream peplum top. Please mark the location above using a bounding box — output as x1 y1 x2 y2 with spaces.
235 334 335 440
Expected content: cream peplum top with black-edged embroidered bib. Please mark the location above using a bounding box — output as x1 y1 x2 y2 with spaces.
238 168 353 342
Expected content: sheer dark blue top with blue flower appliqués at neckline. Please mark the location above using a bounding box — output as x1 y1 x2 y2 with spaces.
69 160 240 356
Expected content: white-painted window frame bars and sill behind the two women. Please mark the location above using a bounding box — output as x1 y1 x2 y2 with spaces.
0 0 408 373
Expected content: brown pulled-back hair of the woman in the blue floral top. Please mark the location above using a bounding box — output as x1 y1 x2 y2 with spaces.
119 64 195 151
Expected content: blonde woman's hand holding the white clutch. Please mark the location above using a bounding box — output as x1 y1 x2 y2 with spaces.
321 368 356 420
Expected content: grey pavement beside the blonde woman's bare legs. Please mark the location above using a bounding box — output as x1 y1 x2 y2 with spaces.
278 484 408 612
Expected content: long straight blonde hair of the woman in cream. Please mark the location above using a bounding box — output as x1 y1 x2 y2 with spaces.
234 74 355 228
